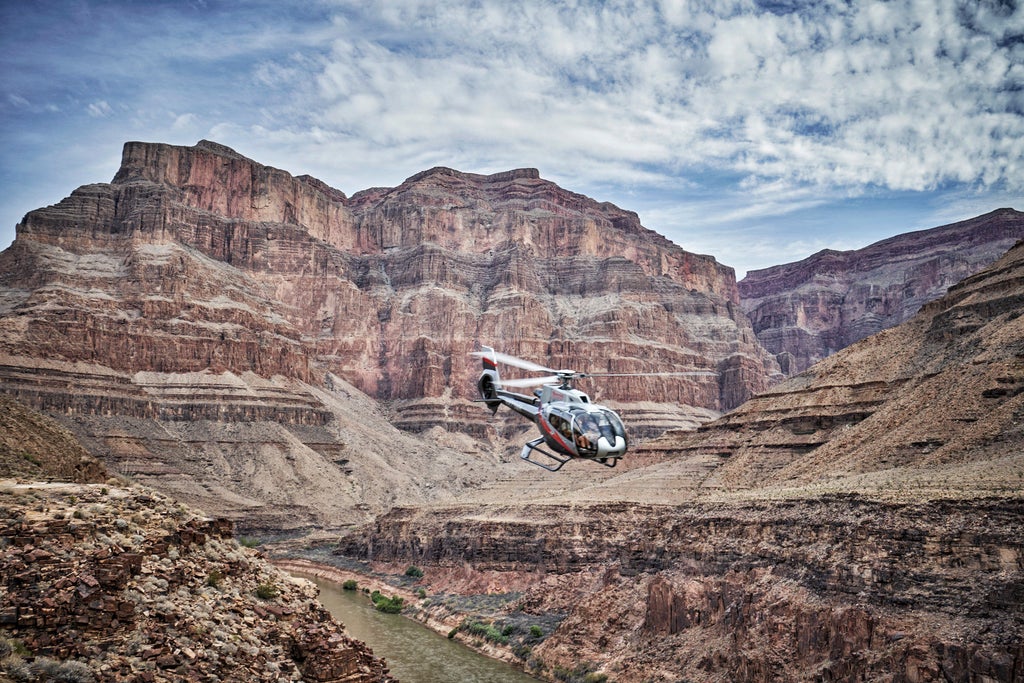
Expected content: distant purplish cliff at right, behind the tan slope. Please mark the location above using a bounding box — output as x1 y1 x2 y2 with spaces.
739 209 1024 375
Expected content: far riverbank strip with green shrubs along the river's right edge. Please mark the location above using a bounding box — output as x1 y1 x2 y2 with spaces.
271 557 553 680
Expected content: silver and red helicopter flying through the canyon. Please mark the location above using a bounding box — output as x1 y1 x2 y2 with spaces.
472 346 718 472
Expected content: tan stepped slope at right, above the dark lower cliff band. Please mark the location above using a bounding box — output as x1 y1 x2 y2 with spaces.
650 243 1024 496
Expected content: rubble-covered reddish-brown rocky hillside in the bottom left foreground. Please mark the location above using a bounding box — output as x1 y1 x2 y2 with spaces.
0 480 393 683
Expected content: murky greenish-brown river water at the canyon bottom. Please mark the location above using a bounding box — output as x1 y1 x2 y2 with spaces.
303 574 537 683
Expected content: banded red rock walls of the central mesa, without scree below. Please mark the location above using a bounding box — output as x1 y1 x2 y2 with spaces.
3 141 775 410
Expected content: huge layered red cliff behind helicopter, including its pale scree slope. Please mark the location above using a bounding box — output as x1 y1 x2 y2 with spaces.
0 141 779 529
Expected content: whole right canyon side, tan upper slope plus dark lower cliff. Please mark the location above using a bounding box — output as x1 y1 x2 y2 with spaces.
337 243 1024 683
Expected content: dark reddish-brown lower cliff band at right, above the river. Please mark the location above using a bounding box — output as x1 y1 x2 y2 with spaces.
338 496 1024 683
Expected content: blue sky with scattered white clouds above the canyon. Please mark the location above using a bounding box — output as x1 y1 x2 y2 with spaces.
0 0 1024 276
